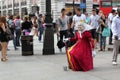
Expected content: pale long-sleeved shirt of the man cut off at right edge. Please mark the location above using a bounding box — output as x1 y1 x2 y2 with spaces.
111 16 120 40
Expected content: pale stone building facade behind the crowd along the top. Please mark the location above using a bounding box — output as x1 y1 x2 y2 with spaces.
0 0 92 21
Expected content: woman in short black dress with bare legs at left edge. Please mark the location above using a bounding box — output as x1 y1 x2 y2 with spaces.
0 16 8 61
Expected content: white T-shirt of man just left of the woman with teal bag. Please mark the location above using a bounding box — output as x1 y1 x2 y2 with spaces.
90 15 100 29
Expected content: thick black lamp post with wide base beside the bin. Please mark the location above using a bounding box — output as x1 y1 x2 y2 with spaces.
43 0 55 55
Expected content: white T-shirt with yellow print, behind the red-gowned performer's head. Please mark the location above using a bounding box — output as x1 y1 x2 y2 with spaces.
73 14 86 30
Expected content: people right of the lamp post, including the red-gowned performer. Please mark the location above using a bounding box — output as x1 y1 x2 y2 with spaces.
57 8 120 71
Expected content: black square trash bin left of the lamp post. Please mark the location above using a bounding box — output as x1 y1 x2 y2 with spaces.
21 35 33 56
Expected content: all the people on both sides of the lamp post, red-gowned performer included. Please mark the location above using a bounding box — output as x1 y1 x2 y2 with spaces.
0 8 120 71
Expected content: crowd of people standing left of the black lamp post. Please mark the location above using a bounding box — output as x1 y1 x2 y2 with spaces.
0 14 45 61
